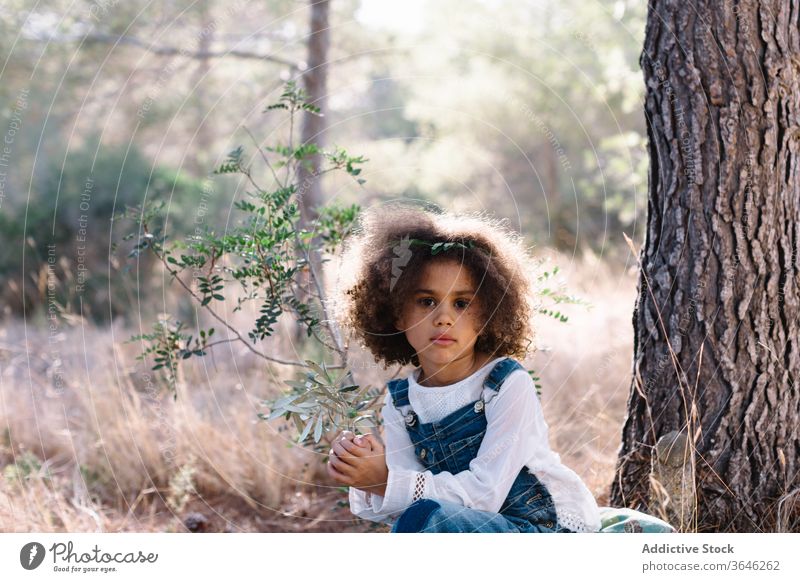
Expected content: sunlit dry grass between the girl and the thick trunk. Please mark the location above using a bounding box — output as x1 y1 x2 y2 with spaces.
529 255 636 505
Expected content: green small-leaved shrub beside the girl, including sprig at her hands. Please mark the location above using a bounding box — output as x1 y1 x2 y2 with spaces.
124 82 382 450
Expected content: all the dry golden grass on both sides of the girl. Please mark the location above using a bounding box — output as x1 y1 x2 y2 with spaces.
0 251 635 532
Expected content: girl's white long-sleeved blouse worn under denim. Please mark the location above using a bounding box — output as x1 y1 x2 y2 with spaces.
349 357 600 532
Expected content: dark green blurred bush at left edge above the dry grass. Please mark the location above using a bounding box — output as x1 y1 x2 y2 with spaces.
0 136 206 321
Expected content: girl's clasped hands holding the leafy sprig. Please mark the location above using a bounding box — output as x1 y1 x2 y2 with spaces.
328 431 389 495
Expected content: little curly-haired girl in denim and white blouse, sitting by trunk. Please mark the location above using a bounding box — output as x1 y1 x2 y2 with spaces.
328 206 600 533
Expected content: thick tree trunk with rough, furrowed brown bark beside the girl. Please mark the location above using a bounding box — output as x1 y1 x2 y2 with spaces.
611 0 800 532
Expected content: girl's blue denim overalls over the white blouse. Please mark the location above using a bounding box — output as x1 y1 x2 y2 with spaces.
388 358 570 533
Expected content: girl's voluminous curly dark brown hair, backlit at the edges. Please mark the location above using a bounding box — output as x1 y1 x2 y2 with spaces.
332 203 535 366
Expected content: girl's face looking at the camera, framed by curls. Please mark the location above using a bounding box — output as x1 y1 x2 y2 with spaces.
395 260 482 369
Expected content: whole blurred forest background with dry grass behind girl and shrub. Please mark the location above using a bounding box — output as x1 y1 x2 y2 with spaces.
0 0 647 531
